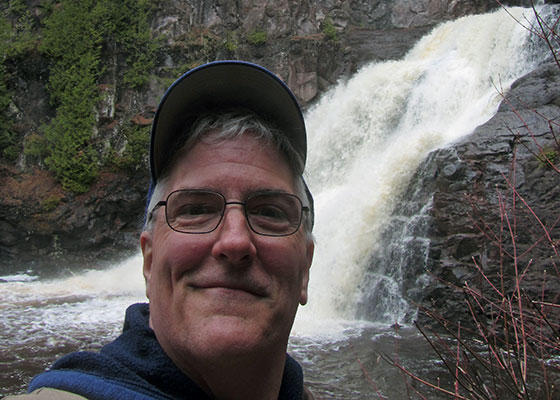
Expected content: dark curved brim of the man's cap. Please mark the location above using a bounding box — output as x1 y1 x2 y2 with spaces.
150 61 307 182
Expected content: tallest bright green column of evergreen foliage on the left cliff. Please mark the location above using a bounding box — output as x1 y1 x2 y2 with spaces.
41 0 106 193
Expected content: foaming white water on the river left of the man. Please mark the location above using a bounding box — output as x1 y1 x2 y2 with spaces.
0 257 145 348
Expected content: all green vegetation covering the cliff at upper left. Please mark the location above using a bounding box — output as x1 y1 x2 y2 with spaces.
0 0 316 193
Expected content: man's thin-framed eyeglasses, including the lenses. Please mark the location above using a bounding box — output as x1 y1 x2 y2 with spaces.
150 189 309 236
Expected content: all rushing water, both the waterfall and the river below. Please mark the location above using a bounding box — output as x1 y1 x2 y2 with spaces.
0 5 552 399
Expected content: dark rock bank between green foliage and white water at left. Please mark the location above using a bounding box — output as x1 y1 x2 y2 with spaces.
0 169 148 274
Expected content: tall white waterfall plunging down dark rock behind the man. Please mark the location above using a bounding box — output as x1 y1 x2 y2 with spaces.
300 8 545 323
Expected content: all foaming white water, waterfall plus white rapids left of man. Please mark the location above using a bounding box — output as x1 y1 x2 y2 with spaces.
0 9 552 398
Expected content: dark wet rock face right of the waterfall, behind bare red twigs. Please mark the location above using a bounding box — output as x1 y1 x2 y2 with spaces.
401 64 560 326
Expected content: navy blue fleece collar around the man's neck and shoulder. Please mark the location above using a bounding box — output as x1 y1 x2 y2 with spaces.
29 304 304 400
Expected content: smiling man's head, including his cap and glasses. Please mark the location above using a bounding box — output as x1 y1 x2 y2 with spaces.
141 62 313 386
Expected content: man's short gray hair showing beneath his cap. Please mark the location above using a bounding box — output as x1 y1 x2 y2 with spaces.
144 110 314 239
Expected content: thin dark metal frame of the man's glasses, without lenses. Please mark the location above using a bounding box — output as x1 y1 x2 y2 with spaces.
148 189 310 237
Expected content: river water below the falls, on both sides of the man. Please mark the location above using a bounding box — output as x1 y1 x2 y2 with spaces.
0 255 448 399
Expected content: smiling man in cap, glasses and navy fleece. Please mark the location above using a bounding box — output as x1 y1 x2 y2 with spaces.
9 61 314 400
